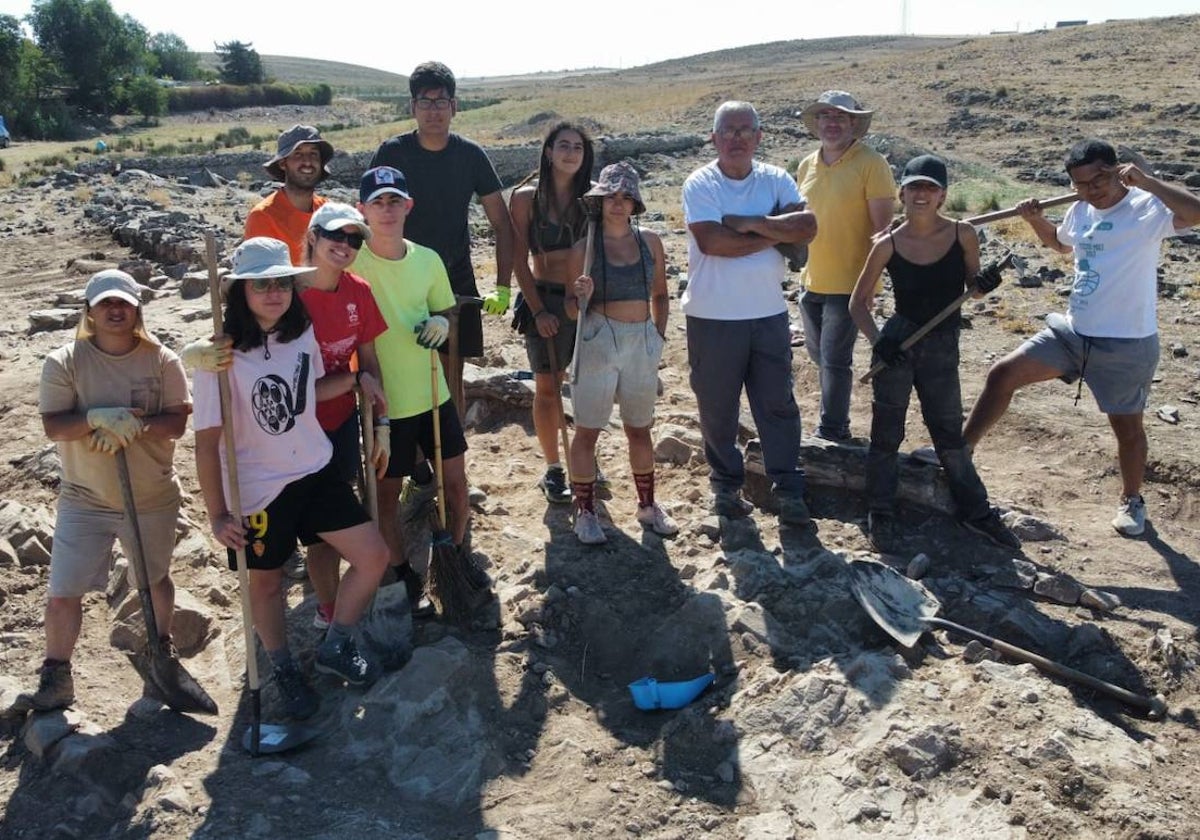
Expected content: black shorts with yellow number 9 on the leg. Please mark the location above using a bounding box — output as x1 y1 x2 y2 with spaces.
227 463 371 570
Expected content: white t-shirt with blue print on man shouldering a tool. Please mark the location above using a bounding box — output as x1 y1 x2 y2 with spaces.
1057 188 1175 338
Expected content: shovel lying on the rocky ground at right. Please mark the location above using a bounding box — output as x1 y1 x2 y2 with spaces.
850 560 1166 720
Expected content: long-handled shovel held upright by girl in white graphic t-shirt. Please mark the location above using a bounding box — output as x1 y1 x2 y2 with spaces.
204 233 318 757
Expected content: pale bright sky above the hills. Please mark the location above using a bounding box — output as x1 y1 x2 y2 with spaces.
0 0 1200 78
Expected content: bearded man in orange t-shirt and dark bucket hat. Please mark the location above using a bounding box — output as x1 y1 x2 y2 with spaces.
244 125 334 263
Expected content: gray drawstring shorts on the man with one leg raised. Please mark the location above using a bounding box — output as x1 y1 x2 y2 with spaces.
1018 313 1158 414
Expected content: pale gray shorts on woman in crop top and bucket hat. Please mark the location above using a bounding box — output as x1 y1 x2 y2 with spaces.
571 313 662 428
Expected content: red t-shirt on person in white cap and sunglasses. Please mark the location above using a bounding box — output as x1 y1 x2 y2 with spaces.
300 271 388 432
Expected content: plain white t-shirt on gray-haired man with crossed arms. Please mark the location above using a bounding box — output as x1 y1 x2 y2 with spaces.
680 161 800 320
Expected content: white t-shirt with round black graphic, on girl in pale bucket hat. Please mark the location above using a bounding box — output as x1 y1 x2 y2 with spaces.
192 326 334 516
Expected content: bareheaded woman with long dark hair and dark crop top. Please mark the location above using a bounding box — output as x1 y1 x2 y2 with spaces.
509 121 594 504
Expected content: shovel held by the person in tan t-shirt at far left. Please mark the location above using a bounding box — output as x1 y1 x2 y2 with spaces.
116 449 217 714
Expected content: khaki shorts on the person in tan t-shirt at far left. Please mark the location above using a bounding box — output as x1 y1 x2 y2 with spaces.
49 498 179 598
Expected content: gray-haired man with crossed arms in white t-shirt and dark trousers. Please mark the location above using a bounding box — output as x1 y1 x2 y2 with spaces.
682 102 817 526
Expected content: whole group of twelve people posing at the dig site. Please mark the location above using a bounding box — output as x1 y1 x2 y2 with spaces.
14 62 1200 718
